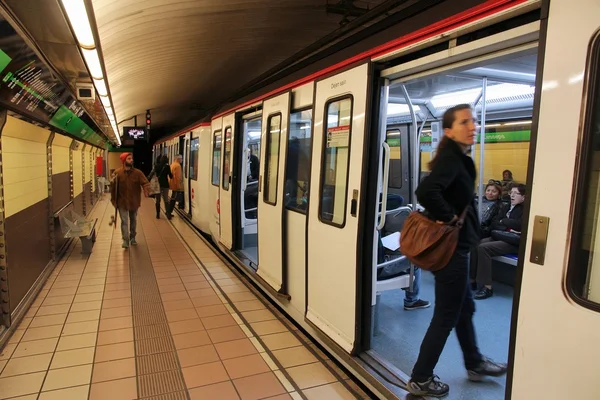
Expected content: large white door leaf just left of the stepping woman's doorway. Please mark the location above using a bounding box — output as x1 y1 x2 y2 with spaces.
306 63 370 353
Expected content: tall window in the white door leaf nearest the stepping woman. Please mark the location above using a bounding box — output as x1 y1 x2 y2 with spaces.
319 98 352 227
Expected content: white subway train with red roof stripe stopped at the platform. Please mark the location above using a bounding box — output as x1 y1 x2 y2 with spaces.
153 0 600 400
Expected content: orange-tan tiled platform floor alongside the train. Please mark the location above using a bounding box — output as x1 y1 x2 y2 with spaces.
0 195 369 400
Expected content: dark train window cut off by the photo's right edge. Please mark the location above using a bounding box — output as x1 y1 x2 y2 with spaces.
568 36 600 309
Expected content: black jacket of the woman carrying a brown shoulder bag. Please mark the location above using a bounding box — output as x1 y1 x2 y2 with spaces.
416 139 480 248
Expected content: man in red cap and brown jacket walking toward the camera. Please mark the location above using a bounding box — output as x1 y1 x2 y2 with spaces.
110 153 150 248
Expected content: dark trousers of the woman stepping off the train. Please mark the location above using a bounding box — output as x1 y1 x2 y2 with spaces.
412 249 482 382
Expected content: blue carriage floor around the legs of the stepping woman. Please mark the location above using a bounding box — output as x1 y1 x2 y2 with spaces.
373 271 513 400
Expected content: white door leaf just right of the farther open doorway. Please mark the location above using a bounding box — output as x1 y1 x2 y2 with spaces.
257 92 290 291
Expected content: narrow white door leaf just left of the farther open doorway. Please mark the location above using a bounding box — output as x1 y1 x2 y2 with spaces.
219 113 235 249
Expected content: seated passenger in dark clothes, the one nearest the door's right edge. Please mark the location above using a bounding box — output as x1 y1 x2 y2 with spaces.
471 185 526 300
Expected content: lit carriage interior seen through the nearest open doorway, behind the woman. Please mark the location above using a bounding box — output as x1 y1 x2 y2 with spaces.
370 49 537 399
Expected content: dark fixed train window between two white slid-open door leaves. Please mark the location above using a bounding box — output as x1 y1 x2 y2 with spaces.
285 110 312 214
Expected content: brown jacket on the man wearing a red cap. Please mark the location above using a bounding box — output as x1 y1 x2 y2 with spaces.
110 168 150 211
